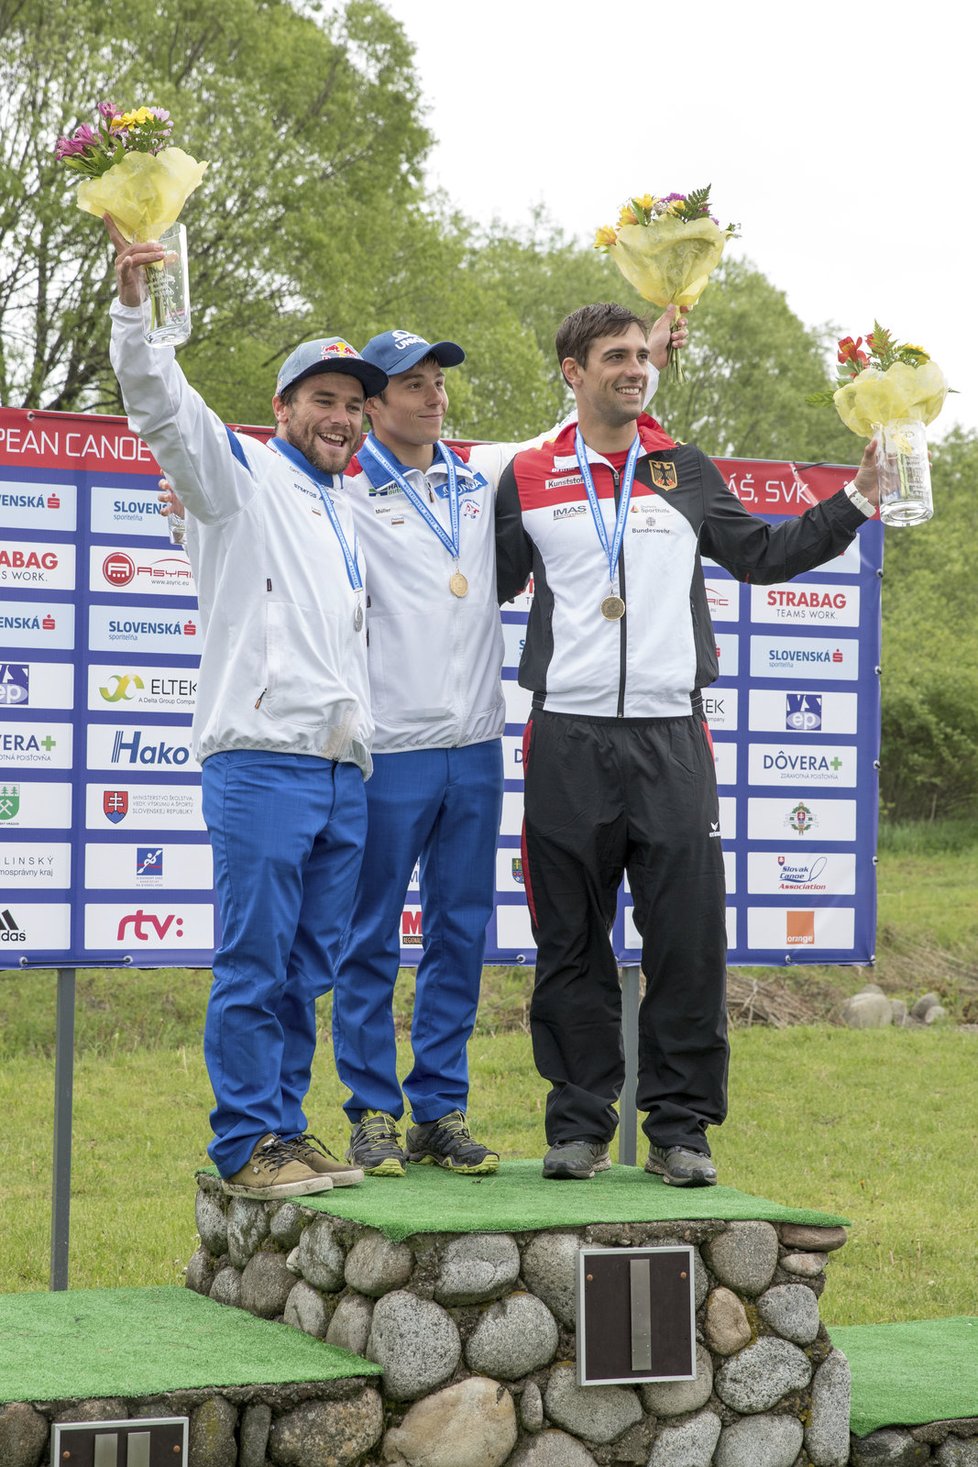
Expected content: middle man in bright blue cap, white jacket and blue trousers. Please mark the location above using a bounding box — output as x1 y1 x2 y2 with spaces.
333 312 686 1177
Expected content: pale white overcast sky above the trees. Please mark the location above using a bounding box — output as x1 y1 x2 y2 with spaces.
384 0 978 436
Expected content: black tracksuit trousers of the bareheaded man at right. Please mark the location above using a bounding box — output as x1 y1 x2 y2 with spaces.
523 709 729 1153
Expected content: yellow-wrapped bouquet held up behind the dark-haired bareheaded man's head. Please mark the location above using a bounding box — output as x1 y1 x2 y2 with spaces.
594 185 738 381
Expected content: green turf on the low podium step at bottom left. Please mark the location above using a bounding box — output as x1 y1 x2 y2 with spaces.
0 1287 380 1401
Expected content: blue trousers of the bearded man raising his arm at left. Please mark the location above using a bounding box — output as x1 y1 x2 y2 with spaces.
202 750 367 1177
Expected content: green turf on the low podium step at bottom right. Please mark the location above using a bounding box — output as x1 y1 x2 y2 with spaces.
828 1316 978 1436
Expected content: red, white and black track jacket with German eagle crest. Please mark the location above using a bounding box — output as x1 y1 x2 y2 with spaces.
496 414 865 717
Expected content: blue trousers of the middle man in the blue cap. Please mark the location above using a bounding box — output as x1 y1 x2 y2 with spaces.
333 739 503 1122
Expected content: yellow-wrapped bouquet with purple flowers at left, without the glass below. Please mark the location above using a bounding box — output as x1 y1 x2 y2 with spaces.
54 101 207 239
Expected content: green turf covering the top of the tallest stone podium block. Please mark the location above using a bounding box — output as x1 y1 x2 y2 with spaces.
201 1162 849 1243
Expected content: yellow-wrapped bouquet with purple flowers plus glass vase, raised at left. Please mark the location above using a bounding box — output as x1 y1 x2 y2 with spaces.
54 101 207 346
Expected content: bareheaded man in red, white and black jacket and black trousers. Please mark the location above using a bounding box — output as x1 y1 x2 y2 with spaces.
496 305 878 1187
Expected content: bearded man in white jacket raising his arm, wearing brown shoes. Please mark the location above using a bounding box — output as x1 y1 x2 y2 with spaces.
106 219 387 1199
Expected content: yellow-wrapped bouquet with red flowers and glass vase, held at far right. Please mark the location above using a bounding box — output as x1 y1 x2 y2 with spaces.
806 321 947 525
